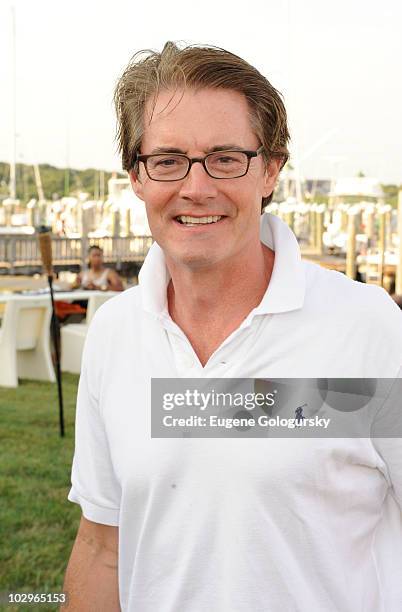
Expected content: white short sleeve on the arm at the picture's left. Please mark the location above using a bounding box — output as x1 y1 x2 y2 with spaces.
68 320 121 526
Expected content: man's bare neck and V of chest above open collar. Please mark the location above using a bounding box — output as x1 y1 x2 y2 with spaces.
168 242 275 365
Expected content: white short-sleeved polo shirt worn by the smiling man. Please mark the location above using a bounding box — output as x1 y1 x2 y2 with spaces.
69 214 402 612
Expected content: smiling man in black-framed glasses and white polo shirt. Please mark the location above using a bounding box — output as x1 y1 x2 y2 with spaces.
65 43 402 612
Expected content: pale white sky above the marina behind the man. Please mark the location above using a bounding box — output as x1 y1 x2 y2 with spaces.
0 0 402 183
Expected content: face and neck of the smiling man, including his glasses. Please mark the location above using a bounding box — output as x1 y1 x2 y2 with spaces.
130 87 286 365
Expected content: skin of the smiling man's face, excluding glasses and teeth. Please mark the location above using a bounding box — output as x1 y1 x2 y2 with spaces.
130 89 279 268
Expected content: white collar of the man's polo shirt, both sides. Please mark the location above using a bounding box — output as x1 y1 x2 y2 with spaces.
138 213 305 319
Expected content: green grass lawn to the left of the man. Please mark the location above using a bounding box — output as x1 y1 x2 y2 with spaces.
0 374 81 612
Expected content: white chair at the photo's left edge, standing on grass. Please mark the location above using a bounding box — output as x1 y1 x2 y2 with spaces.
0 297 56 387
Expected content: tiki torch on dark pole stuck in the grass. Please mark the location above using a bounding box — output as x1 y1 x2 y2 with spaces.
37 225 64 437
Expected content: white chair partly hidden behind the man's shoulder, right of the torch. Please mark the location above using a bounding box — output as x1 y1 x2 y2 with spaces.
61 292 115 374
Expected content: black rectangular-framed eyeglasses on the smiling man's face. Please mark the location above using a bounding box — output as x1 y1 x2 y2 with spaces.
133 146 264 181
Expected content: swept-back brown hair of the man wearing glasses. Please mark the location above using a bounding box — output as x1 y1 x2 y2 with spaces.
114 42 290 208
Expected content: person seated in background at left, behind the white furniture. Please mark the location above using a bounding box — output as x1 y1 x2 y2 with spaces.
74 245 124 291
